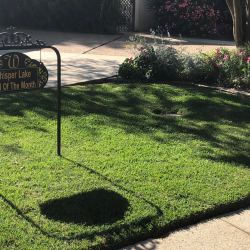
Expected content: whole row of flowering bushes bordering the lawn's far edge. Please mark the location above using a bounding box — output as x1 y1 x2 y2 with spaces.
118 32 250 89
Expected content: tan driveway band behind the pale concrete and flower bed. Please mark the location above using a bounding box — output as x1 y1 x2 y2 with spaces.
10 30 235 57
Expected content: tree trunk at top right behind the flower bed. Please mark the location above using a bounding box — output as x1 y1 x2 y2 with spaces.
226 0 250 47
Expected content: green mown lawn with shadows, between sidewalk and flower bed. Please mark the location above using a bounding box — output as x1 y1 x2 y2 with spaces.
0 84 250 250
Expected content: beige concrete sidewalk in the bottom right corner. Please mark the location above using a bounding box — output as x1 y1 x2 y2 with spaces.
120 208 250 250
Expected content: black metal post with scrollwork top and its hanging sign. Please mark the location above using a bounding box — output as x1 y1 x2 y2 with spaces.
0 27 61 156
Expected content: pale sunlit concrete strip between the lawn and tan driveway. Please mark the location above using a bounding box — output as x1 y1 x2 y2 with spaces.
22 52 125 88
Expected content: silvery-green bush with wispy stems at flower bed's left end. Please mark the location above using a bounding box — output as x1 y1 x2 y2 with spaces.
118 31 182 80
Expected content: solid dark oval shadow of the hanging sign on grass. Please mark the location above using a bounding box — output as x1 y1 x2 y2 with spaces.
40 189 129 226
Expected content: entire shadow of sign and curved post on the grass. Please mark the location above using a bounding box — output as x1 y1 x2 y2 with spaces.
0 157 163 241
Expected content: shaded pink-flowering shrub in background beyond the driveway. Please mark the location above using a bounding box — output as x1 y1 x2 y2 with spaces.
153 0 232 37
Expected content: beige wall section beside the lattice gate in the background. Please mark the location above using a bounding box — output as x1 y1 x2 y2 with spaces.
135 0 154 31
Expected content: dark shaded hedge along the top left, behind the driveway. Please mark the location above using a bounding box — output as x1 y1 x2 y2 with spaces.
0 0 119 33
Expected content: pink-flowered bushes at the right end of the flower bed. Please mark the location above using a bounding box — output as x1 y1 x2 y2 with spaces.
178 47 250 89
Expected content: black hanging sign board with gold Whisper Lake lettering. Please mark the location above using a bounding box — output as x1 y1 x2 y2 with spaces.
0 52 48 92
